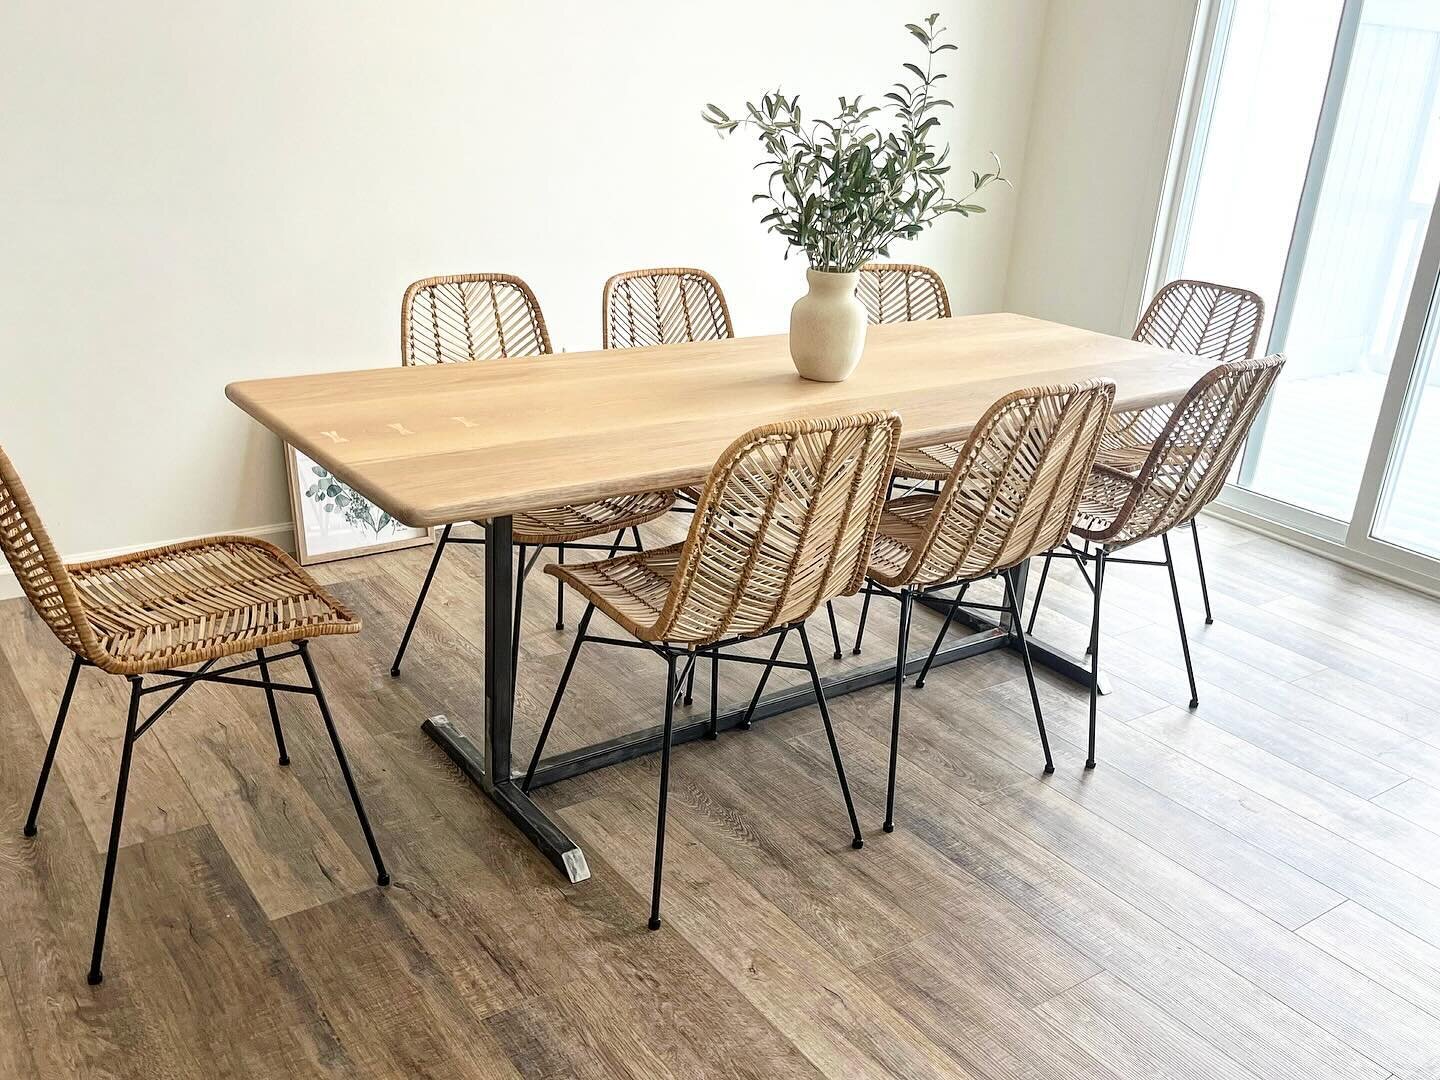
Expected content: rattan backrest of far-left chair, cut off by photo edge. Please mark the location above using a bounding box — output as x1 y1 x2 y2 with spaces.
0 448 102 661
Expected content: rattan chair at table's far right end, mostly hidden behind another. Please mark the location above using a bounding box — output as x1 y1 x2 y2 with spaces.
1099 278 1264 624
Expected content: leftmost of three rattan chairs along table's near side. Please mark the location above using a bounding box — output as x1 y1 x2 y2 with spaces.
523 413 900 930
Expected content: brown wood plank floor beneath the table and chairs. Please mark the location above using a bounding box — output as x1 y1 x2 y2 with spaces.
0 523 1440 1080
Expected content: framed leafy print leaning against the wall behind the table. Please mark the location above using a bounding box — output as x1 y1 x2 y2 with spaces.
285 444 432 566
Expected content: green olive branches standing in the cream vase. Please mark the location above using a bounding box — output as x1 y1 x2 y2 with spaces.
701 13 1009 274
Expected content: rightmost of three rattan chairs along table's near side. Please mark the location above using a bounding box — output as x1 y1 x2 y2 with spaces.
1031 356 1284 769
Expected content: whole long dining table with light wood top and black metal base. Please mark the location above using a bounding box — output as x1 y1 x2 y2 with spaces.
226 314 1211 881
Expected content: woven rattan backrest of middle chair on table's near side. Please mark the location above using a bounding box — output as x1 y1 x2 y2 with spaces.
906 379 1115 585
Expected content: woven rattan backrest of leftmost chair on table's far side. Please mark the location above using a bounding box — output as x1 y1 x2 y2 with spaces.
400 274 550 364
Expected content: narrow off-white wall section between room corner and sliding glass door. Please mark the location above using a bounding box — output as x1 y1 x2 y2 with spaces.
1004 0 1197 336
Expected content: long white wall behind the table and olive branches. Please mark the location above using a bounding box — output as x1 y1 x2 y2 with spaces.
0 0 1050 576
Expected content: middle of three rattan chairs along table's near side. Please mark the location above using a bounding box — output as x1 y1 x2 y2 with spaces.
865 380 1115 832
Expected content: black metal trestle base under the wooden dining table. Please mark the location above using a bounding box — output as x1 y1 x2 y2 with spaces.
420 517 1104 883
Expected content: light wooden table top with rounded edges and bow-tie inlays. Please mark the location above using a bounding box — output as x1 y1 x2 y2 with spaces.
225 314 1211 526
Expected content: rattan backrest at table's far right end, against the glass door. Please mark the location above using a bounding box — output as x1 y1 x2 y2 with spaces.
1135 278 1264 363
